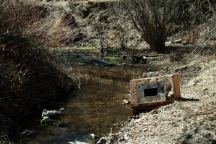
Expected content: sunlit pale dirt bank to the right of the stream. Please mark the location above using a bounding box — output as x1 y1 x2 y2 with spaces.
101 55 216 144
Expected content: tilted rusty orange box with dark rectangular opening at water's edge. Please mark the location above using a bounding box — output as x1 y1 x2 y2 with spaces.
130 73 181 112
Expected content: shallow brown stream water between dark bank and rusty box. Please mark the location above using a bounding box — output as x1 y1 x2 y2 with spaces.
18 62 148 144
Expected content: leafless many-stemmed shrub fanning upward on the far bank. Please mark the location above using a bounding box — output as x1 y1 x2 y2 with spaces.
123 0 179 52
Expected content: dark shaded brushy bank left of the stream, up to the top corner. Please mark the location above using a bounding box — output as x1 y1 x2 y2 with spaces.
0 0 73 139
